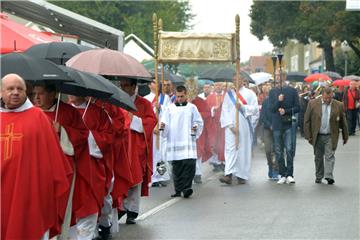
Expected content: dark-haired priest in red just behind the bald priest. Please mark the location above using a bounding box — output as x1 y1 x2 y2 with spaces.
33 85 103 238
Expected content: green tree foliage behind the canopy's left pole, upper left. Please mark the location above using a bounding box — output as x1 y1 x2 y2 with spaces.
52 0 194 46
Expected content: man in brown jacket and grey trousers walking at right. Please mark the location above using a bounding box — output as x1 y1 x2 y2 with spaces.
304 87 349 184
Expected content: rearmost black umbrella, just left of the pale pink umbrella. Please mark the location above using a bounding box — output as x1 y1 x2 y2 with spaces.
25 42 92 65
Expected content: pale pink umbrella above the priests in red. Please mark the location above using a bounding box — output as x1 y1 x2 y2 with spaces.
66 49 151 79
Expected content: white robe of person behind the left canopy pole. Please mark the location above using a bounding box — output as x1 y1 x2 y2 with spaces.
144 92 171 183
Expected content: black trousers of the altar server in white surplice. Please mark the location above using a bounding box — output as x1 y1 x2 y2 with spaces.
172 158 196 193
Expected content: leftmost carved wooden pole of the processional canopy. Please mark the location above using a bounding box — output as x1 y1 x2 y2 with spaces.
152 13 160 149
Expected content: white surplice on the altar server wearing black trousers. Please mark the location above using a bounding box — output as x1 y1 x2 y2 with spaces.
161 103 204 161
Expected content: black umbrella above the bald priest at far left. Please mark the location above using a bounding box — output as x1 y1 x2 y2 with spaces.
0 53 72 83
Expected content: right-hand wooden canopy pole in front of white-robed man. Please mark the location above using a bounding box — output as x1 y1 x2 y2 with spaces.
235 14 240 149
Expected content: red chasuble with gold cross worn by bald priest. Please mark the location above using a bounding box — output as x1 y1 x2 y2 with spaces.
0 107 71 240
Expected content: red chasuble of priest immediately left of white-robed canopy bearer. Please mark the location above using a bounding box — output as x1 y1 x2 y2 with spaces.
206 93 225 161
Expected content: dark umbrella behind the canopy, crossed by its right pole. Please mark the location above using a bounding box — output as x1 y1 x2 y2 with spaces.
199 67 255 83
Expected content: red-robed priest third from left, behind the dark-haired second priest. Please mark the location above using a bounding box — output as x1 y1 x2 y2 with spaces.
68 95 114 239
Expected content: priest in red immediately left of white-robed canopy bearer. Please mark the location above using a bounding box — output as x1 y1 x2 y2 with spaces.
206 82 225 171
